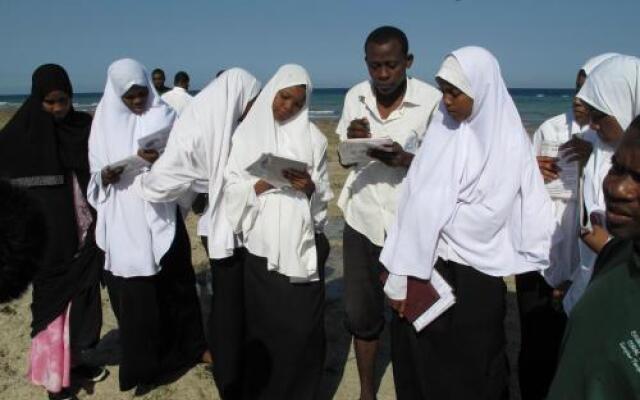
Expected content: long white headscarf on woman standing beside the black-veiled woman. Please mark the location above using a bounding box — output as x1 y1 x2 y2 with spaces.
88 58 176 277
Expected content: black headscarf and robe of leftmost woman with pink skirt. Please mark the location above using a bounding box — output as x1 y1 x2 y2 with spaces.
0 64 101 336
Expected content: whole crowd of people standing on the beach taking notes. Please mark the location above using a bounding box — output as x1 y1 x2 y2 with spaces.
0 26 640 400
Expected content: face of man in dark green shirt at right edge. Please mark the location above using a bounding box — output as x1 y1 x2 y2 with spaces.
603 127 640 247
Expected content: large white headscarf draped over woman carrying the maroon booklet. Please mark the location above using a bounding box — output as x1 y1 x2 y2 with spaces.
380 47 553 279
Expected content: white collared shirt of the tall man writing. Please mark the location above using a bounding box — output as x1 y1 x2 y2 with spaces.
336 78 442 246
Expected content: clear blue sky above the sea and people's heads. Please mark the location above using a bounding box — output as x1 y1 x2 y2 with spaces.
0 0 640 94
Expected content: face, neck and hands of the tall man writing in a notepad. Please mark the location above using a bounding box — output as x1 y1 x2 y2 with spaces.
343 39 413 168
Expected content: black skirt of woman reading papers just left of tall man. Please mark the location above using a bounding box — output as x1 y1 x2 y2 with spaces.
243 235 328 400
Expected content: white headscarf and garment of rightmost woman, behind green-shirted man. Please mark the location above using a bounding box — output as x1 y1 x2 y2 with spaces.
563 55 640 313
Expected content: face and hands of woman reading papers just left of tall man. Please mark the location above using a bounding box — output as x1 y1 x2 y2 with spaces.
254 85 316 198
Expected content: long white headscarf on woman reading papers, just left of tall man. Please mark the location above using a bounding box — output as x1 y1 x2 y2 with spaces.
224 64 319 280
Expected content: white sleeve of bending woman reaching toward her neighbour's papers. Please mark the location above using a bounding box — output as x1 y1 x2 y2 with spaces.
134 129 209 203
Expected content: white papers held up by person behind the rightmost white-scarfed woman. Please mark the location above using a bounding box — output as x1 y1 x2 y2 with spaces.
540 140 580 199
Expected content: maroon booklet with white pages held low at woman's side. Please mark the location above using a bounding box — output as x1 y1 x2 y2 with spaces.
382 269 456 332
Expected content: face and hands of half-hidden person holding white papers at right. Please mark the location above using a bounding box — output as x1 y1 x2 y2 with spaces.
537 70 593 183
